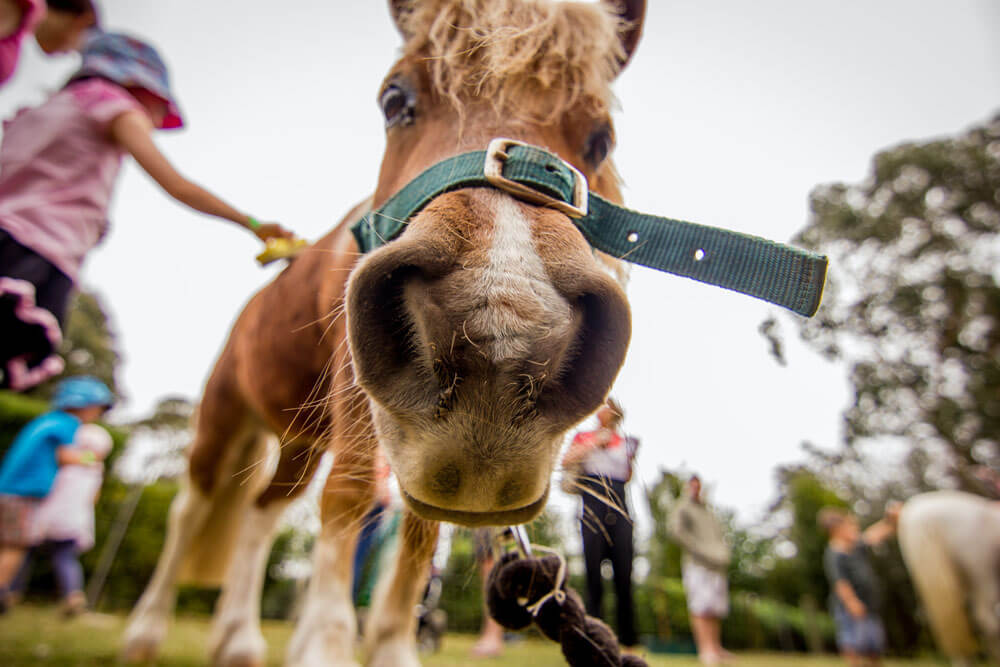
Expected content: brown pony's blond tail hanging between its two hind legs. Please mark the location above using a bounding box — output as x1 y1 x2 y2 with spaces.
178 432 279 588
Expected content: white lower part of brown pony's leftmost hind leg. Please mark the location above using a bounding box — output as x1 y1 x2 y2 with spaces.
122 483 212 662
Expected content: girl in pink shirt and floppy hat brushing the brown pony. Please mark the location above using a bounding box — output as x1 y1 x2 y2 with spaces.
0 33 291 391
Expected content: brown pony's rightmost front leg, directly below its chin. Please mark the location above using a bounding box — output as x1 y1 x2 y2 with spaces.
365 512 438 667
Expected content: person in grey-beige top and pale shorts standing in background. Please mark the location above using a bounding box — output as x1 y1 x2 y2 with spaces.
667 475 732 665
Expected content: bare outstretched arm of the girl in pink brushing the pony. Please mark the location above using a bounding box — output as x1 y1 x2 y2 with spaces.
109 111 293 241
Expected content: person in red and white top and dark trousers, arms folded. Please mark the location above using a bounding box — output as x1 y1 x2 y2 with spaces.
562 398 639 647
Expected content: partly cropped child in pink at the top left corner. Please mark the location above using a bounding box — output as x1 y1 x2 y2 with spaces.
0 0 97 85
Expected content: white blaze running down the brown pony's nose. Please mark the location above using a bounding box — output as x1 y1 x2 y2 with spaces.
466 193 570 362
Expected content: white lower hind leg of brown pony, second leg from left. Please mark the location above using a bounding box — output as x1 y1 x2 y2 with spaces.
209 499 289 665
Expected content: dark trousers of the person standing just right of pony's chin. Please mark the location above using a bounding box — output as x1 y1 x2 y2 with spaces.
580 477 638 646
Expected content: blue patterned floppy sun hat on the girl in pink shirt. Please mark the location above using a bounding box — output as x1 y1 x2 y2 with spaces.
73 32 184 130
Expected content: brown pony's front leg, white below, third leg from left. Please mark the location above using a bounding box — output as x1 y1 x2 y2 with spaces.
287 440 375 667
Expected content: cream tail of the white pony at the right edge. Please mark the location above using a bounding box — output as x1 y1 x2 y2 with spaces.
899 498 978 659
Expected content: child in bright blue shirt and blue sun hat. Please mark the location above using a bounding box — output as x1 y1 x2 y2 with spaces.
0 376 114 612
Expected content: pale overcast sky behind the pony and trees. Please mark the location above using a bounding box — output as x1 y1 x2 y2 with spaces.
0 0 1000 521
